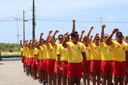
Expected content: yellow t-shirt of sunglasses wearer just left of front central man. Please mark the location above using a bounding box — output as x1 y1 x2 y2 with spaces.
57 44 69 61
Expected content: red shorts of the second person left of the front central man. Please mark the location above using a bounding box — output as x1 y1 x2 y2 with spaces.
46 59 55 73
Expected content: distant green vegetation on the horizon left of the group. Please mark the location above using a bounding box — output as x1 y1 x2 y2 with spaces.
0 43 20 52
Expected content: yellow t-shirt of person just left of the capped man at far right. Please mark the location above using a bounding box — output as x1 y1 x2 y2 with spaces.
100 42 112 61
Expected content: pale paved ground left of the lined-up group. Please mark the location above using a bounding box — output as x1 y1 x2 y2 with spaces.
0 59 42 85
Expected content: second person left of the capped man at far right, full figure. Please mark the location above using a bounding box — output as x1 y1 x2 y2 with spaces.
89 33 101 85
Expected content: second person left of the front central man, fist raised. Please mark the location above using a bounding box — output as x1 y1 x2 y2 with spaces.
46 30 58 85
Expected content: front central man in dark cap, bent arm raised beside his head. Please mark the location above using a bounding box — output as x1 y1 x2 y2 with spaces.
62 31 86 85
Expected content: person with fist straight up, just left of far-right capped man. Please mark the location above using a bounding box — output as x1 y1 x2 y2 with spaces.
100 25 112 85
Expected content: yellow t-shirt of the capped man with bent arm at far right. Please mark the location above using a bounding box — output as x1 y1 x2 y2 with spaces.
111 40 128 61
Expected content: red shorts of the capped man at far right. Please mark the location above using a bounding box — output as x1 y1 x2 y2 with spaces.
112 61 126 77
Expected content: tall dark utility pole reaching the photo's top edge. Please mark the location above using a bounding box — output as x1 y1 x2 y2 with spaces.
32 0 36 40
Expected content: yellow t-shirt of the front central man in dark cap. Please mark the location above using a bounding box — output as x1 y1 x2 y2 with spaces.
67 42 85 63
